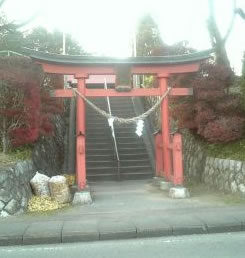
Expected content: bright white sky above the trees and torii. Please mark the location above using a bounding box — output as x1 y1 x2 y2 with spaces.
3 0 245 73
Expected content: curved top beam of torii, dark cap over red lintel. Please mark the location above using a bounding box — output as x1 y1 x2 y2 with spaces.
22 48 213 78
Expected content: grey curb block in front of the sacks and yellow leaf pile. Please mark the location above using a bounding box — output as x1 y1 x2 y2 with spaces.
23 221 63 245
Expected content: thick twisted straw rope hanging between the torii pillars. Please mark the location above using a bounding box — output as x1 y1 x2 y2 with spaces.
71 87 172 125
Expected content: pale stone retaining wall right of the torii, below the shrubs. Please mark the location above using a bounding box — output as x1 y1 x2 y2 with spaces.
183 133 245 194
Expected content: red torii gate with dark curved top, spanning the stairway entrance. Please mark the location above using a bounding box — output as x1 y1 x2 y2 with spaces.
24 49 212 190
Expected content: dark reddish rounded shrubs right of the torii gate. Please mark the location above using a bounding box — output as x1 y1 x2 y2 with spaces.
171 63 245 143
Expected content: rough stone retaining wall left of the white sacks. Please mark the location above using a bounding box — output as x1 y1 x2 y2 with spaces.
0 160 36 217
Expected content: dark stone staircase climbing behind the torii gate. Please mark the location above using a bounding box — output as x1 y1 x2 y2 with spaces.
86 90 153 181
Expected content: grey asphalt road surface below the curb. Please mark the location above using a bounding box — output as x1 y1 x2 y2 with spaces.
0 232 245 258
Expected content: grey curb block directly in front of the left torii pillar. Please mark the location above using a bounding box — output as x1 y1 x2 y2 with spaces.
62 220 100 243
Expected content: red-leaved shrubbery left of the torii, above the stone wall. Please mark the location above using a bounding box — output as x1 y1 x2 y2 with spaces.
0 57 63 149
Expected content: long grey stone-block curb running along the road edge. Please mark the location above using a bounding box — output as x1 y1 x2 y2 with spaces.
0 221 245 246
